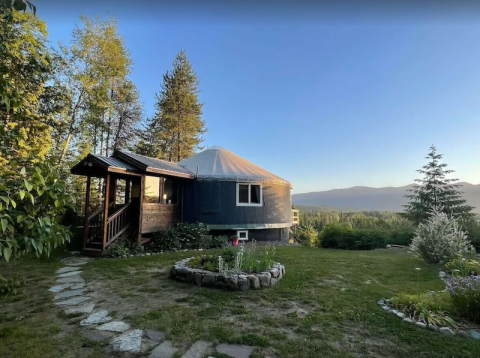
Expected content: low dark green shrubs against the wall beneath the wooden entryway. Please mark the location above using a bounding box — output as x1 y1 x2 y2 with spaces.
145 223 213 251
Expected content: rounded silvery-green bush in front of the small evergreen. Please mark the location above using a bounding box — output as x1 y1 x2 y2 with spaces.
410 210 472 263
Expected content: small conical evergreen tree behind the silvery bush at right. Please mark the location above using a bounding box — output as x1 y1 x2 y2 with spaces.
404 145 473 222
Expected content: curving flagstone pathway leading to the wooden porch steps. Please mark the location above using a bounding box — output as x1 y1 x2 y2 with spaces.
49 256 254 358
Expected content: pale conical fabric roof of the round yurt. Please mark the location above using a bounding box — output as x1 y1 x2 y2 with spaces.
178 147 291 186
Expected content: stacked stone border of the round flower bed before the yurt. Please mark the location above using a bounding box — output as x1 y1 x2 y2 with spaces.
170 257 286 291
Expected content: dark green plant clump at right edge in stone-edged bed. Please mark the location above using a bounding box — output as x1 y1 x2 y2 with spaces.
446 276 480 323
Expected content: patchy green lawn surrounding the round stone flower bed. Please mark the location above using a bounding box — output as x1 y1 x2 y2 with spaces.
0 247 480 358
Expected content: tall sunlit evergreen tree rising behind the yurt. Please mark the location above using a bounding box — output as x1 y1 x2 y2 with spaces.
150 50 203 161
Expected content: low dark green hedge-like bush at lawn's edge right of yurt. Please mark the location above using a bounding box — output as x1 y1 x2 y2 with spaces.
319 223 386 250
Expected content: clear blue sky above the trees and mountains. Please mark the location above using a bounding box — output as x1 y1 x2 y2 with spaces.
35 0 480 193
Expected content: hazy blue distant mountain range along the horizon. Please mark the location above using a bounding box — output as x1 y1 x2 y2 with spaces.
292 182 480 213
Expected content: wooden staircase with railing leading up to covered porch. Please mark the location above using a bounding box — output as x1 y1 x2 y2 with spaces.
82 202 132 256
